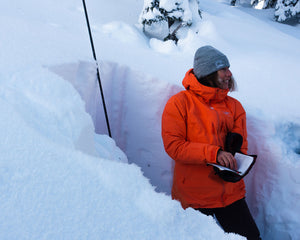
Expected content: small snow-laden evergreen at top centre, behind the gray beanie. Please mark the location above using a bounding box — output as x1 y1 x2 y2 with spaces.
139 0 201 42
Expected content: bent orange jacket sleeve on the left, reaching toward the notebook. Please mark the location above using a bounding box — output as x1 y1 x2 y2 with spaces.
162 95 220 164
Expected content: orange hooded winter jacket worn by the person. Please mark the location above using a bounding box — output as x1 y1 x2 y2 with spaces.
162 69 248 208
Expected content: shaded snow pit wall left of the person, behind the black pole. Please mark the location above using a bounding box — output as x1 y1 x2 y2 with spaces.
50 62 182 194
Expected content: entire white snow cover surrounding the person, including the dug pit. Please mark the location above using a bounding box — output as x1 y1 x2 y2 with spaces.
0 0 300 240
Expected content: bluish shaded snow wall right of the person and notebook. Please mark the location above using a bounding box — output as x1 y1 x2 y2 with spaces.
245 111 300 240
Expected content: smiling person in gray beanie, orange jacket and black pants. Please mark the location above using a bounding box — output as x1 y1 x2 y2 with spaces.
162 46 260 239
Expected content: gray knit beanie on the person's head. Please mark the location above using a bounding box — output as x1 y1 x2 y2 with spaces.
194 46 230 79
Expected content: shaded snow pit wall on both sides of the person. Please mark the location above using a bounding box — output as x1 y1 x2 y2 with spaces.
50 62 300 240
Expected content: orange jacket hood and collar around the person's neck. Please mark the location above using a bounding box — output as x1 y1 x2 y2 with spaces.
182 69 229 102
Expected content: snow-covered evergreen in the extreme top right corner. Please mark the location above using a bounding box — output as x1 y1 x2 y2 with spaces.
275 0 300 22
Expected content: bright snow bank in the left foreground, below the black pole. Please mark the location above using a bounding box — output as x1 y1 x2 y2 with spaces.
0 68 242 240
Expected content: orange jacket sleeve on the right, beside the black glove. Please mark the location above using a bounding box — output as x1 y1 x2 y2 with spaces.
232 100 248 154
